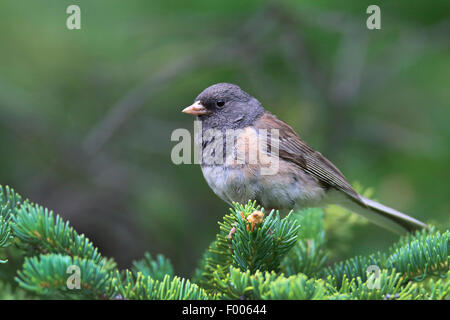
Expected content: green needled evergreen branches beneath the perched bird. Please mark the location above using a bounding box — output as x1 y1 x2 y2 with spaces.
0 182 450 300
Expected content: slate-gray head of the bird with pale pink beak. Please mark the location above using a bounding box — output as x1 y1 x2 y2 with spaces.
183 83 264 129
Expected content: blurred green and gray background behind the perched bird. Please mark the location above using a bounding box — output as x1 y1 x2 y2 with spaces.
0 0 450 276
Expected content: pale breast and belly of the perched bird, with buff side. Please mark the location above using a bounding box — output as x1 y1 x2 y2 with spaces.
197 127 324 209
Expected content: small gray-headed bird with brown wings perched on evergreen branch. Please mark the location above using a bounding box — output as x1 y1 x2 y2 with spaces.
182 83 427 233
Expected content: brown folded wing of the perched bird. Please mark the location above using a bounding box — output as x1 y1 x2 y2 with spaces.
255 112 361 202
